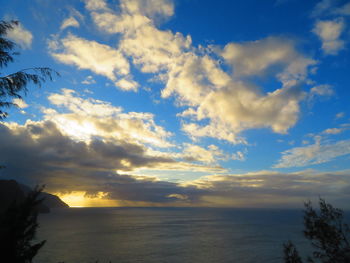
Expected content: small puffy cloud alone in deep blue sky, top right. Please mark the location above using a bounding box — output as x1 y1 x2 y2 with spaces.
312 18 345 55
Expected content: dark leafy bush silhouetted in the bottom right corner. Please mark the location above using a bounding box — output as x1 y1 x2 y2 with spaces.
284 199 350 263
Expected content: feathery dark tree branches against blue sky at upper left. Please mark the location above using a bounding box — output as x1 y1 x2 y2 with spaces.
0 21 59 120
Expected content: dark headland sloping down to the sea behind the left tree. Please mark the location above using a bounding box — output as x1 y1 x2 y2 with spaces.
0 180 69 213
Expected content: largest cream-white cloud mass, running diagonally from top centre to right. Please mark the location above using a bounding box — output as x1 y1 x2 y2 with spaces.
82 0 316 143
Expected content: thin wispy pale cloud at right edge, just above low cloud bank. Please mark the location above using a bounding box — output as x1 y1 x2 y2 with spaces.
274 137 350 168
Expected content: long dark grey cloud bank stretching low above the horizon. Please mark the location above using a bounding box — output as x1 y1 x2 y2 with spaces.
0 121 350 207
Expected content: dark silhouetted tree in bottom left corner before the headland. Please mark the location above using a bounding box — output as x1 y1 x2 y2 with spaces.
0 187 46 263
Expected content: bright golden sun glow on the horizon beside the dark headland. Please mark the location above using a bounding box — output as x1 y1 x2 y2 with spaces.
56 191 119 207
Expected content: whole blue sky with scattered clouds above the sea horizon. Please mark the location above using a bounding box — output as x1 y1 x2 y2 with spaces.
0 0 350 208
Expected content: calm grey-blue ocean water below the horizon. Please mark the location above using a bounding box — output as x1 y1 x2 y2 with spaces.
35 208 308 263
